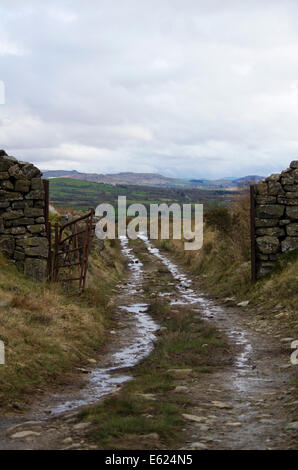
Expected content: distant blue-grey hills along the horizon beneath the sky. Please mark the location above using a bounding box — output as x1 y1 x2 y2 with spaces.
43 170 263 189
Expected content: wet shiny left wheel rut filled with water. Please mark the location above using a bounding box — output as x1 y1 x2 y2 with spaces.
43 237 159 416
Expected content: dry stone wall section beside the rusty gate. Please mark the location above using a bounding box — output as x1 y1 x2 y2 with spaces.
0 150 48 281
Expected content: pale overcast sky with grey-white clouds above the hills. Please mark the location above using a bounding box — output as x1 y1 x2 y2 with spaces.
0 0 298 178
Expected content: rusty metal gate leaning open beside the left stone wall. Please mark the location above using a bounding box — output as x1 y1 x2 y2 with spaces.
49 209 94 294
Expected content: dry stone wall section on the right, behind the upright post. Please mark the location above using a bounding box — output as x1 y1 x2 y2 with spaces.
254 160 298 278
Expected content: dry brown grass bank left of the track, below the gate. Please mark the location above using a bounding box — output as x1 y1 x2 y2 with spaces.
0 237 121 407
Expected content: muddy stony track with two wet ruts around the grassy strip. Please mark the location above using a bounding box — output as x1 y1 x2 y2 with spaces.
0 236 298 450
